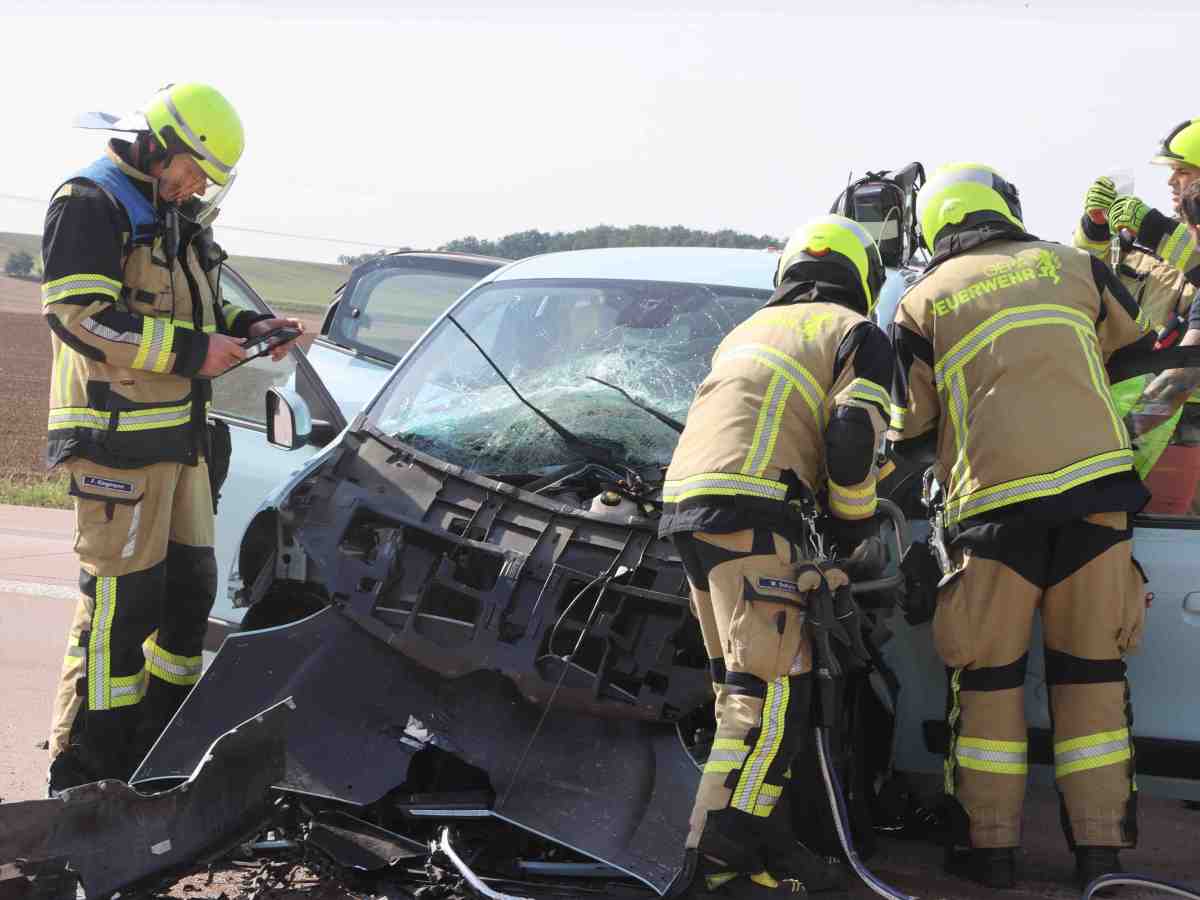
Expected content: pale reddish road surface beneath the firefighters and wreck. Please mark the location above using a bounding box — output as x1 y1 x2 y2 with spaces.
0 506 1200 900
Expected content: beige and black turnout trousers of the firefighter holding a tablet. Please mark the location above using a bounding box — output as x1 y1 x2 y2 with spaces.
49 458 216 778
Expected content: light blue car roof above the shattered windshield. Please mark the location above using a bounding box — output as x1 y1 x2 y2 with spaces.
485 247 779 290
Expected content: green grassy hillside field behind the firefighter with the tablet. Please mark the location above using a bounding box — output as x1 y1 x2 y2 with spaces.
0 232 350 311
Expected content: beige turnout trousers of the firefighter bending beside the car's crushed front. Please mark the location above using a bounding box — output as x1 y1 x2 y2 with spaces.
674 529 845 871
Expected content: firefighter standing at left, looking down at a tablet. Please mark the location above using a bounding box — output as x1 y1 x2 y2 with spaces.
42 84 302 796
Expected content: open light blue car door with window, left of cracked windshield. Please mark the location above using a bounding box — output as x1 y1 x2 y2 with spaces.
308 253 505 419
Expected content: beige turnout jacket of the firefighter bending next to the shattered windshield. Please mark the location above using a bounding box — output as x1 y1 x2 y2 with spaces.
659 282 893 535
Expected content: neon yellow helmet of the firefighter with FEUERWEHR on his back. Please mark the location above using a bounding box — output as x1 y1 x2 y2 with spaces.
917 162 1025 250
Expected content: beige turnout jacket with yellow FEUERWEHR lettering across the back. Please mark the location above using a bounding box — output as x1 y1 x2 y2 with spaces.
890 230 1152 526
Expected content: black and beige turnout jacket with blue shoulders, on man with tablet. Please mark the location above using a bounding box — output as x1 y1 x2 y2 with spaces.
42 140 268 468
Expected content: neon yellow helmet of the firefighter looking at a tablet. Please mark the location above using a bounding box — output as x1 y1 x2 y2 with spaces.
144 83 246 185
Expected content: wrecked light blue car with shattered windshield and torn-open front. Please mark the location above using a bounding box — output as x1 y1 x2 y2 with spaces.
63 237 1180 894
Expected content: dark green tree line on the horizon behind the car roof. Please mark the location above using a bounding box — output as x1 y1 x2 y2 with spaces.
337 226 784 265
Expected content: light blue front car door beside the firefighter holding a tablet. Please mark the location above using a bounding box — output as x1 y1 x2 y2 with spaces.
209 266 346 622
